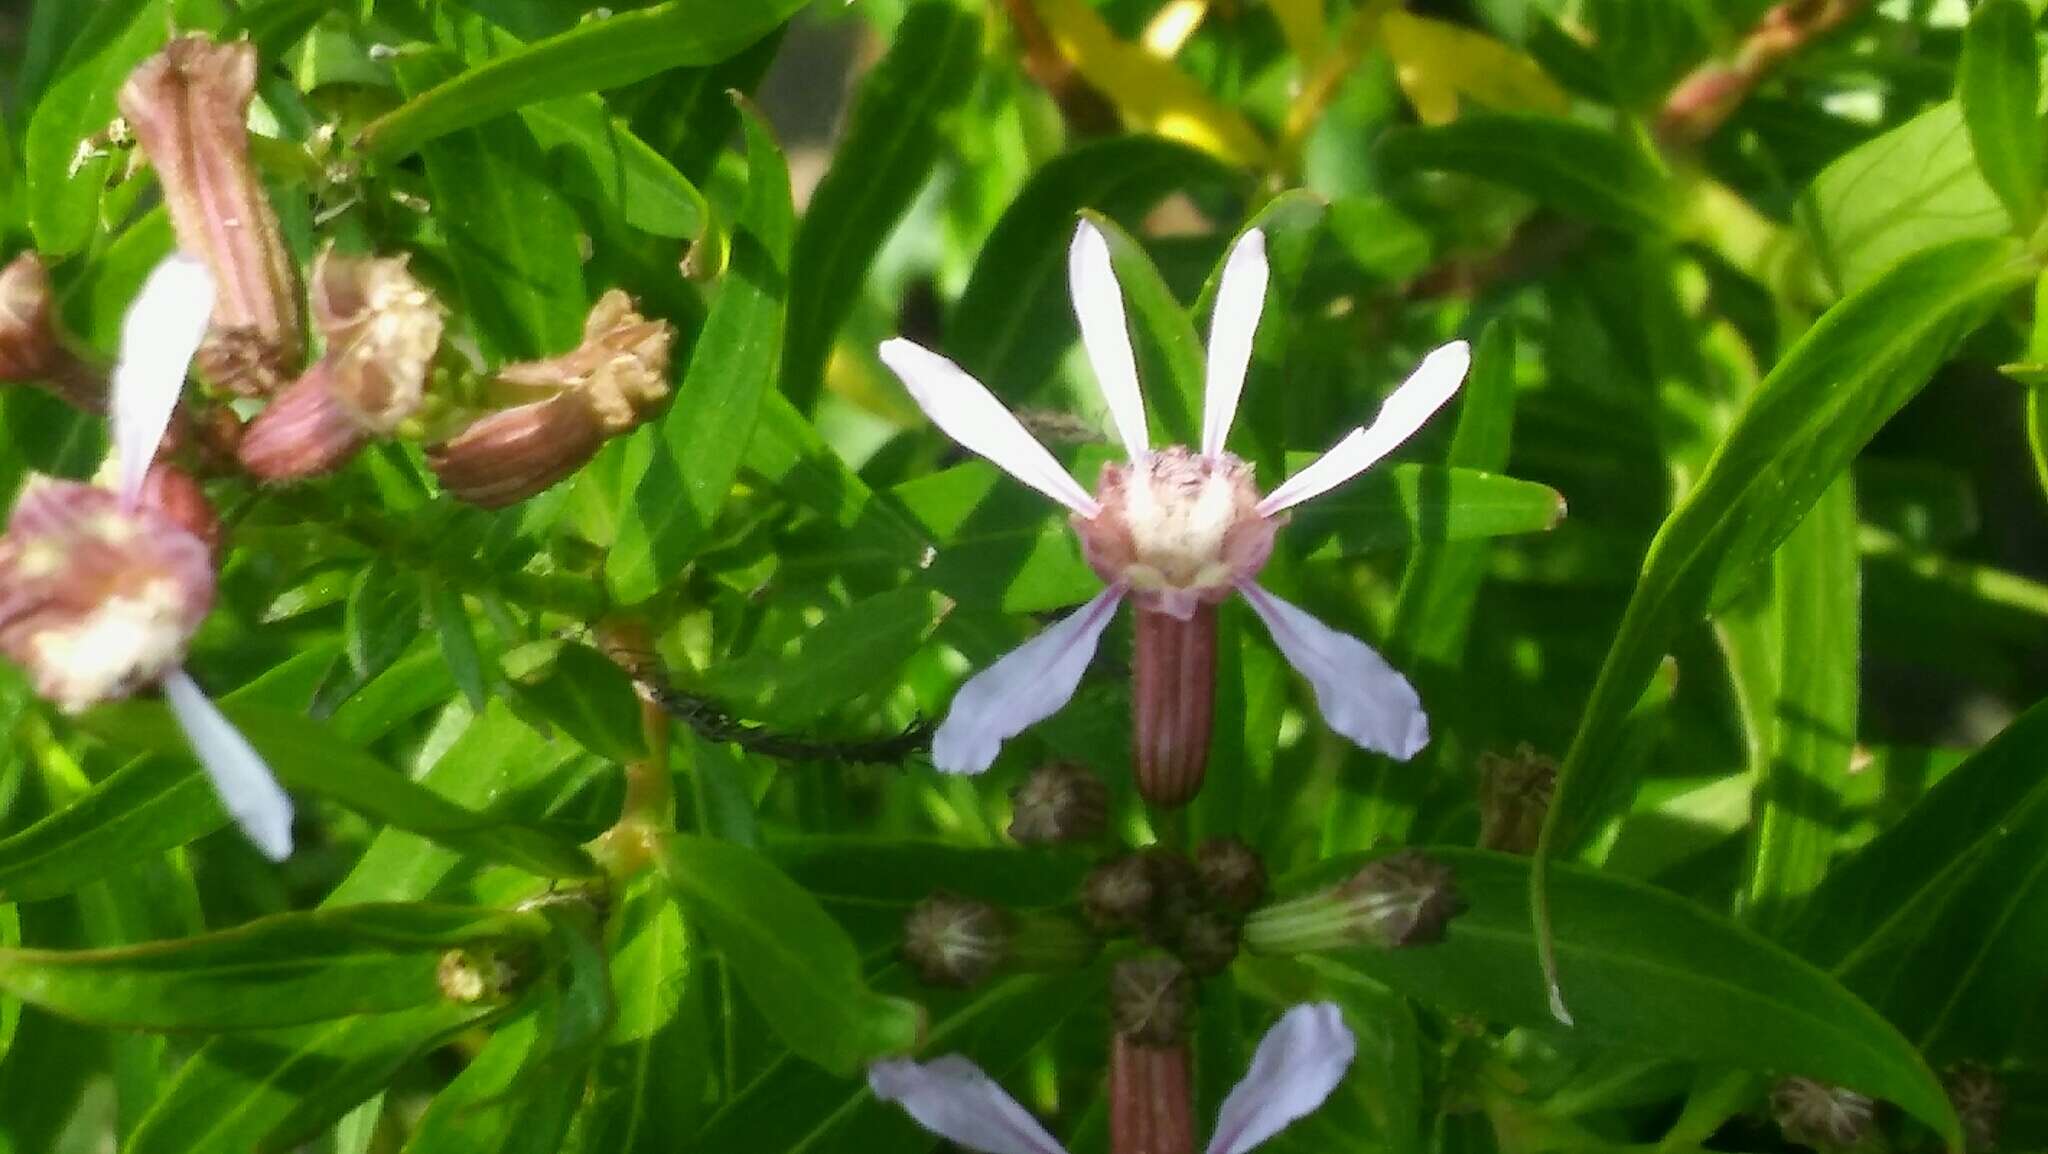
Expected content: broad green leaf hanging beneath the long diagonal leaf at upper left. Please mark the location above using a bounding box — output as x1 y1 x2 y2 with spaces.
393 49 584 359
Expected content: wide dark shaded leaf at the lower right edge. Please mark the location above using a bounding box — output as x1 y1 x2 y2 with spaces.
1788 705 2048 1062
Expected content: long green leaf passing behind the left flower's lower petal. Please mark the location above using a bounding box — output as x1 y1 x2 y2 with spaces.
82 701 598 877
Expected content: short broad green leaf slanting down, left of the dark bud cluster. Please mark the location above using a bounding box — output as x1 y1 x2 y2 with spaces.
662 834 924 1076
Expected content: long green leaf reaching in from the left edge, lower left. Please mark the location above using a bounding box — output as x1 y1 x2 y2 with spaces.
0 904 547 1031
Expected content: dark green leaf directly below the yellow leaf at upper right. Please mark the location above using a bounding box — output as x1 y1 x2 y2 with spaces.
1374 113 1673 236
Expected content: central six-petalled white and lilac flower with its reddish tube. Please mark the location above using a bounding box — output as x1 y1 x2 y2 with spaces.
881 221 1470 782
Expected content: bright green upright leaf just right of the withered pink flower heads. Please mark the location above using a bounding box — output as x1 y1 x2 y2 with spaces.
604 107 795 603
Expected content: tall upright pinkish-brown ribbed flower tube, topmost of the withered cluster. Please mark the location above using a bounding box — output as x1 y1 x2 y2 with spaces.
119 35 303 396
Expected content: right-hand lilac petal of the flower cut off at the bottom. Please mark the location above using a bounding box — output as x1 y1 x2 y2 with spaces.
1208 1002 1358 1154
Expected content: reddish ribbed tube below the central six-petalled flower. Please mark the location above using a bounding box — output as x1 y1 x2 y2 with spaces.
1130 605 1217 810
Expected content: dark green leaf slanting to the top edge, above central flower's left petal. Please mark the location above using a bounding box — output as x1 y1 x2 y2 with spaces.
782 0 983 412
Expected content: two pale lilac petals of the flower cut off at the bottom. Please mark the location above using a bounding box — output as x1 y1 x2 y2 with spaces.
868 1002 1358 1154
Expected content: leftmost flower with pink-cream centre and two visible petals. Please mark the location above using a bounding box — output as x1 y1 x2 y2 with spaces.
0 254 291 861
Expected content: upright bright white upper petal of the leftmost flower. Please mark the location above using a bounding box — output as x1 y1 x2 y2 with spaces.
109 252 213 506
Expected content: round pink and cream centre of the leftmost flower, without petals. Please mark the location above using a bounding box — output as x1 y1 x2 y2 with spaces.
0 478 213 713
